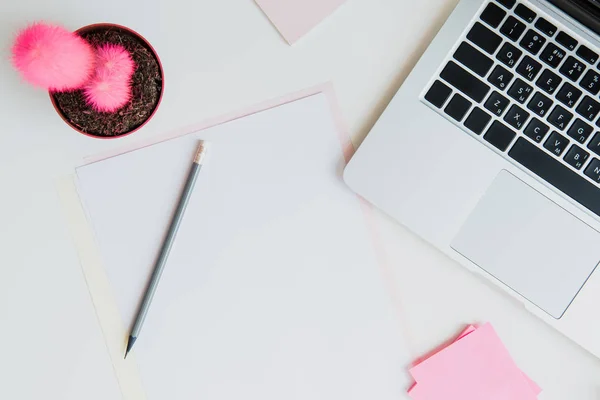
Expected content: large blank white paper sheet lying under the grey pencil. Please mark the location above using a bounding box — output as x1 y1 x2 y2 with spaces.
77 94 407 400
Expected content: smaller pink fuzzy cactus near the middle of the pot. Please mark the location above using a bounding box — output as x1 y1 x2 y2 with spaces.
84 44 135 112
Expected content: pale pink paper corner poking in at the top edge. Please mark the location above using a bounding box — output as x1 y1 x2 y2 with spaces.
256 0 346 44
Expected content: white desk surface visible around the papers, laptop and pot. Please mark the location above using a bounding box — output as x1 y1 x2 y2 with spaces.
0 0 600 400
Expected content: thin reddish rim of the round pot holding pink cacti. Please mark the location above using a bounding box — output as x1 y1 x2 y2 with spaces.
49 23 165 139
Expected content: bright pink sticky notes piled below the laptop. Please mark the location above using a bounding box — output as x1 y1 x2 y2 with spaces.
410 324 537 400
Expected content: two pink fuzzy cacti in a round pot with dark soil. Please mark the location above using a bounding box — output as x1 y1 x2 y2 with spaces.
12 23 164 138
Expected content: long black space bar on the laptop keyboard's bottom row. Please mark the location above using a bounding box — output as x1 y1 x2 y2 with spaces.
508 138 600 216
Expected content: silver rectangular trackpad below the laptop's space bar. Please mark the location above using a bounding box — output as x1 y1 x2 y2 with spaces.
451 171 600 318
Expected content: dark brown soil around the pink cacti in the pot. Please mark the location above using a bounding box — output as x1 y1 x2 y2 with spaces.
50 24 163 138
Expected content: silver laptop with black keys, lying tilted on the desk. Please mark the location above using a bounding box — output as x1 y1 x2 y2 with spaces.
344 0 600 356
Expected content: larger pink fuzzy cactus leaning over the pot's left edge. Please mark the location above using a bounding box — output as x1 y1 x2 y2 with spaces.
12 22 94 92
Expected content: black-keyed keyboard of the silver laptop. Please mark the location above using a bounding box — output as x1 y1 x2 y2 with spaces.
423 0 600 216
